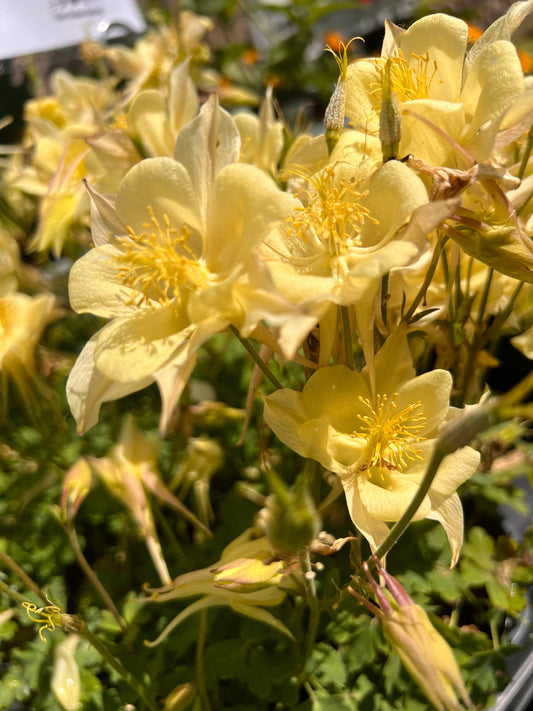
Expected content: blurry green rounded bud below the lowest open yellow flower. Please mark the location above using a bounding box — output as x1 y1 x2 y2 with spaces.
259 471 321 557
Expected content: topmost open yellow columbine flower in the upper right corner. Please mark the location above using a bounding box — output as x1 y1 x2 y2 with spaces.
345 7 533 165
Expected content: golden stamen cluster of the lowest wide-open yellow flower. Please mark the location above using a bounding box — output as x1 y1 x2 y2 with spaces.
352 394 427 471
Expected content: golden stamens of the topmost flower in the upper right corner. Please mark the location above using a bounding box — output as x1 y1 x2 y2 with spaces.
371 50 437 103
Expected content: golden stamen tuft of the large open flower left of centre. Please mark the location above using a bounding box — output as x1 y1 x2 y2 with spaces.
117 205 209 311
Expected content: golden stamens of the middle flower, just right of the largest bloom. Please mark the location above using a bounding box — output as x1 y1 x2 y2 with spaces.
287 166 377 256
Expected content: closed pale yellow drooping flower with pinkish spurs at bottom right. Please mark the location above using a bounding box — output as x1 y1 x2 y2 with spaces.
348 559 473 711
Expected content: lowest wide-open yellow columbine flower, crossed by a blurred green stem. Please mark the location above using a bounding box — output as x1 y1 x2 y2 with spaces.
263 330 479 565
